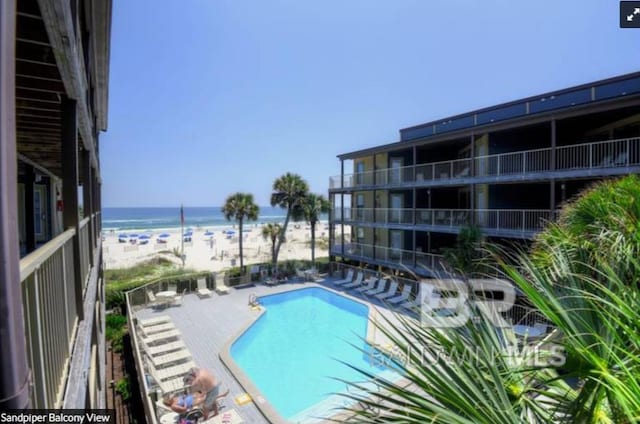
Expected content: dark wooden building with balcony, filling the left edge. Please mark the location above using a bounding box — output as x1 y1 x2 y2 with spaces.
0 0 111 411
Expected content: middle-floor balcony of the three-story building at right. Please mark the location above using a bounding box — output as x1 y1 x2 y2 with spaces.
333 208 556 238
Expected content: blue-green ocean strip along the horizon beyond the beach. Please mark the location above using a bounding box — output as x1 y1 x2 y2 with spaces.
102 206 328 231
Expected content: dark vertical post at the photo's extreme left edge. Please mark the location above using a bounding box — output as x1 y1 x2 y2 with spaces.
0 0 29 411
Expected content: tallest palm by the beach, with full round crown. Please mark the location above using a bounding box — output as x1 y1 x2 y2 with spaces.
271 172 309 267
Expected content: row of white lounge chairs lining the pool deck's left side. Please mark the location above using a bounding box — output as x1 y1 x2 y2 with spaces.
138 315 196 393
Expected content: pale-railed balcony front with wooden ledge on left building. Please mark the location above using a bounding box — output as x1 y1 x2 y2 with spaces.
20 212 105 409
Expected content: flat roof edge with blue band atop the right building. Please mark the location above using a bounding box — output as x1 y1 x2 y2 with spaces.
338 72 640 160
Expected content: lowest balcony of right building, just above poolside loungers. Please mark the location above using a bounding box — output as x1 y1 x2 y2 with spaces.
330 243 445 276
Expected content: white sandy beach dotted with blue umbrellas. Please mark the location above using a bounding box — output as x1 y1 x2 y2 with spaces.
102 222 342 271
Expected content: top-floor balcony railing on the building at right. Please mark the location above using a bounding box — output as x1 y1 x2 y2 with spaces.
329 137 640 189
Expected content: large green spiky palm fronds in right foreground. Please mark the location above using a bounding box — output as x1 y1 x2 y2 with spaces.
338 175 640 423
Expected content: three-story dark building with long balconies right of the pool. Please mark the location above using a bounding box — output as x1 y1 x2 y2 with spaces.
329 73 640 277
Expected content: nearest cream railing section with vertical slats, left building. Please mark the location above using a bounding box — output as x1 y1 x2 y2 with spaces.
20 229 78 408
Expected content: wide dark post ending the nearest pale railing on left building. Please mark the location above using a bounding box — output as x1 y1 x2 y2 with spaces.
62 97 84 320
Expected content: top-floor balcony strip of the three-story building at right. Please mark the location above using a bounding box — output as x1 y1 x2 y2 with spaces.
329 137 640 191
